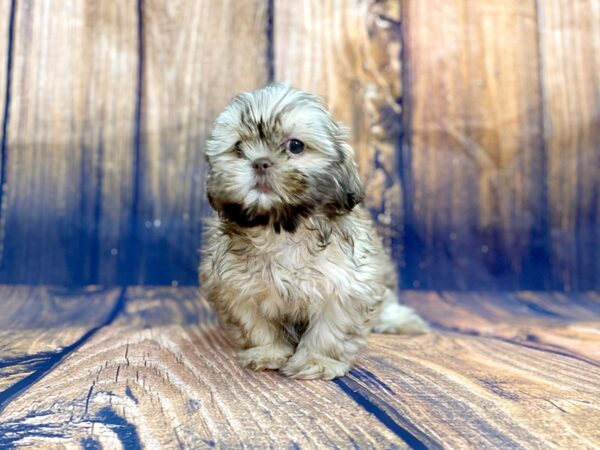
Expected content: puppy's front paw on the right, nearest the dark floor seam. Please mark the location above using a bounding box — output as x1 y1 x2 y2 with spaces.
280 352 350 380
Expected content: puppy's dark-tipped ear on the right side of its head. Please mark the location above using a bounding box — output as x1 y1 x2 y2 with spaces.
324 139 365 216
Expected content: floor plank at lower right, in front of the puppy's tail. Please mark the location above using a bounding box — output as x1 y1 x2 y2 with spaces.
354 333 600 449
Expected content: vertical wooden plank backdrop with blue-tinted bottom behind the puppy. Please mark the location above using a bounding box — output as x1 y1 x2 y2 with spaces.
0 0 600 291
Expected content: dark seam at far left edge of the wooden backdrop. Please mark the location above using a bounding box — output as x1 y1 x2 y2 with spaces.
0 0 17 269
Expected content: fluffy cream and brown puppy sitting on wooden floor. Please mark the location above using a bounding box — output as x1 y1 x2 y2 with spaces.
200 85 427 379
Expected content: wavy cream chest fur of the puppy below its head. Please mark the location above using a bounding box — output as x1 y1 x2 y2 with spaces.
213 216 382 319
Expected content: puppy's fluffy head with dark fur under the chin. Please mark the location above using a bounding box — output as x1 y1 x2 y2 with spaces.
206 85 364 231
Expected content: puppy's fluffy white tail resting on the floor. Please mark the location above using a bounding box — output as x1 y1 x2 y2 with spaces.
373 290 429 335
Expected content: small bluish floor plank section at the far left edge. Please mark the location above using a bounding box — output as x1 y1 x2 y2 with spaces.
0 285 119 396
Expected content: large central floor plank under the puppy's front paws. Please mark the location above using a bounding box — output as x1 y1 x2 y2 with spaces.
0 288 408 448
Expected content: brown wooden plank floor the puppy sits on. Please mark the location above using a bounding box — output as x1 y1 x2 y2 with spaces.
0 286 600 449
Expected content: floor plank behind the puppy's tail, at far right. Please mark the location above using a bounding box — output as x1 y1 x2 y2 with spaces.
402 292 600 364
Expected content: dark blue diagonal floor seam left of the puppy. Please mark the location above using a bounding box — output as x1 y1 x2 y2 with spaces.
0 286 127 414
